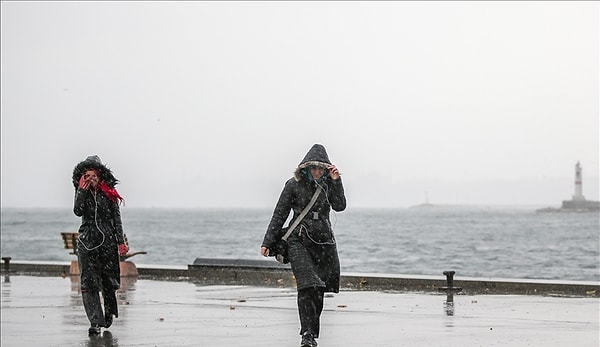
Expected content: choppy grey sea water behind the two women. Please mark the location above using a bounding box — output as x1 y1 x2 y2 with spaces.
1 206 600 281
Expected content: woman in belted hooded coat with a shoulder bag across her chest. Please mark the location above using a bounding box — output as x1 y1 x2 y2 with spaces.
261 144 346 347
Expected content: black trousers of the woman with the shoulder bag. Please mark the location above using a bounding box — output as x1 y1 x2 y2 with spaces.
298 287 325 338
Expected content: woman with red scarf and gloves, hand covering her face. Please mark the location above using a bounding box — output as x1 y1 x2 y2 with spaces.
73 155 129 336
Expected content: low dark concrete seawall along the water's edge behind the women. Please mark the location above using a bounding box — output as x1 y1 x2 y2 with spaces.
2 258 600 297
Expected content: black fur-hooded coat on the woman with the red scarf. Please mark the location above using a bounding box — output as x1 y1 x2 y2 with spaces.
72 156 125 294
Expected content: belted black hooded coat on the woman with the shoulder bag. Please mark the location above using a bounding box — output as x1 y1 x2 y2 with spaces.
262 144 346 293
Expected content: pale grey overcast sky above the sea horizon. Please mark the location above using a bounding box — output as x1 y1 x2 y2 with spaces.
1 1 600 207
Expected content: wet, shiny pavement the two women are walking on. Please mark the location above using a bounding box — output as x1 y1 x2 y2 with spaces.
1 275 600 347
